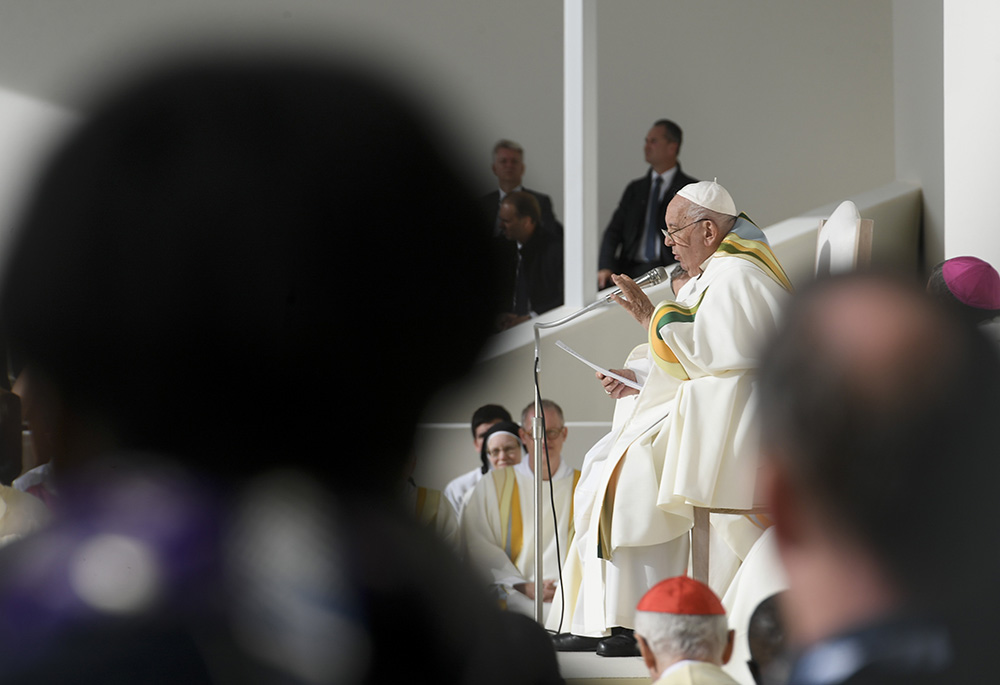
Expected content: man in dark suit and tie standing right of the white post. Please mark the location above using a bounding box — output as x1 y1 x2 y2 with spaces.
597 119 698 288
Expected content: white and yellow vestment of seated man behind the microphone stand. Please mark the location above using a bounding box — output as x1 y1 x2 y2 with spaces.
461 459 580 615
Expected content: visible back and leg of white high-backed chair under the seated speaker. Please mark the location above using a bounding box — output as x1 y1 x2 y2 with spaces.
691 200 875 584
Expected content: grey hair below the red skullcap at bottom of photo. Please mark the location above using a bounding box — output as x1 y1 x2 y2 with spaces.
635 611 729 664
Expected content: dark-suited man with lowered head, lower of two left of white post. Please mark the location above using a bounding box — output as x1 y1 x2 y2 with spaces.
497 191 563 330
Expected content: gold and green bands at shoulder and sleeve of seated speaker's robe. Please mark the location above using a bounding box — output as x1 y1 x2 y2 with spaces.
649 214 792 381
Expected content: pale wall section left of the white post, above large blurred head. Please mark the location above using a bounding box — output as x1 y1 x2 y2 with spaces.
0 0 563 214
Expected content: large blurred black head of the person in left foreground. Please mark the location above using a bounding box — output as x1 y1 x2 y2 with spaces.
0 50 489 488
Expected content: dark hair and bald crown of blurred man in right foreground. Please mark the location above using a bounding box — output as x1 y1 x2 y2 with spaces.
760 275 1000 601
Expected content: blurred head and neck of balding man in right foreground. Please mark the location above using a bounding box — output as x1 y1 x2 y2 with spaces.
760 275 1000 643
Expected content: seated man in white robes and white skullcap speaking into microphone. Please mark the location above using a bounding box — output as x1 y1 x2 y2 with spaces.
549 181 791 656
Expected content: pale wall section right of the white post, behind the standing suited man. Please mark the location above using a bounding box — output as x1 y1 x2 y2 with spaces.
598 0 895 232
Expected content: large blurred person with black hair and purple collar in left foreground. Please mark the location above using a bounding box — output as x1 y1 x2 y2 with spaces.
0 49 558 683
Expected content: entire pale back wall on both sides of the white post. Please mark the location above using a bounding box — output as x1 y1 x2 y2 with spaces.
0 0 895 264
